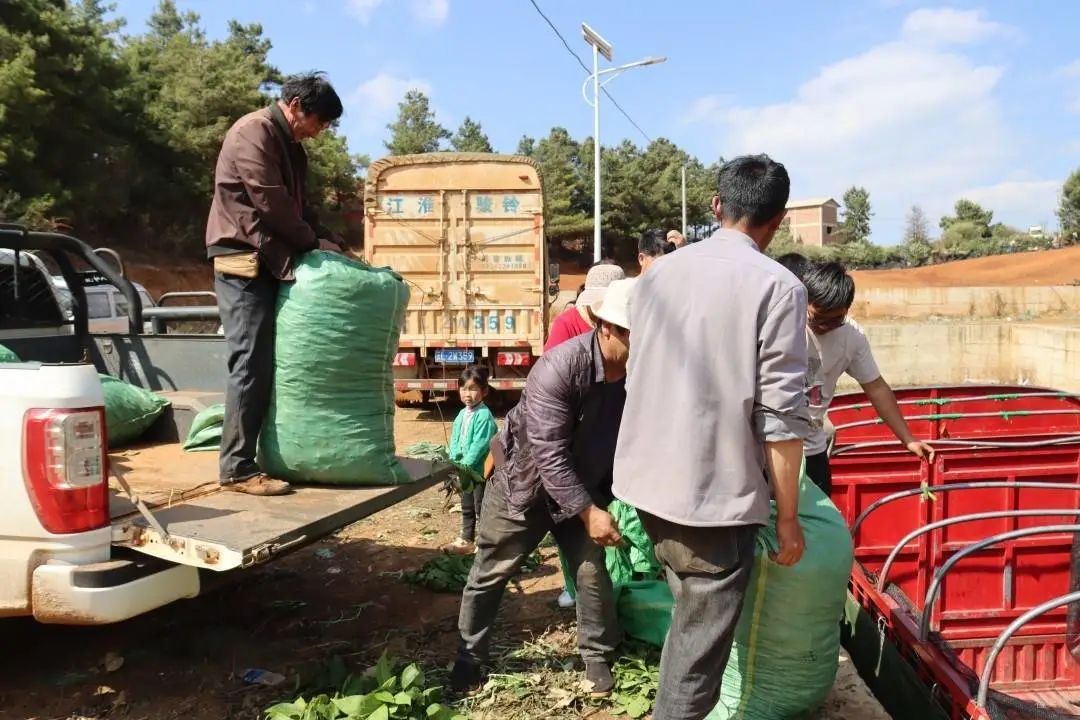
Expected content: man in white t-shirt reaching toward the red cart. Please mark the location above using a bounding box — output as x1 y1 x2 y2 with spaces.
800 262 934 494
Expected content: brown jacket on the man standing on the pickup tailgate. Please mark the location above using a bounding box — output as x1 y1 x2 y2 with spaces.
206 106 319 280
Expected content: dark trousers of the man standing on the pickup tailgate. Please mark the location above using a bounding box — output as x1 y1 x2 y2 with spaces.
214 269 279 483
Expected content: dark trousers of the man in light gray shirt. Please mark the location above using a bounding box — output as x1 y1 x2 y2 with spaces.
637 511 758 720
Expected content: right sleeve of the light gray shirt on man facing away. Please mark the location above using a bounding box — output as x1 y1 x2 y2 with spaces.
754 286 810 443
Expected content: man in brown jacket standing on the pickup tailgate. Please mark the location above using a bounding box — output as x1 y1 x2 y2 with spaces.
206 73 342 495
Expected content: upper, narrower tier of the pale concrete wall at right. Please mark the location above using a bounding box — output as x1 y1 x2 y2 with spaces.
851 285 1080 321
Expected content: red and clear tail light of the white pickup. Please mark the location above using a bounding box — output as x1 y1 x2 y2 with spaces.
23 407 109 534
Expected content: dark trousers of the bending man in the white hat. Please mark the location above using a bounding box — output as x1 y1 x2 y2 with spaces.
458 473 620 665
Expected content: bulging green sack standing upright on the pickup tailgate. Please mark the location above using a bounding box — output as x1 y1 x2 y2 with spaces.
259 250 411 485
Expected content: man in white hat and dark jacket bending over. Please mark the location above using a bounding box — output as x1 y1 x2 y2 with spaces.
450 280 635 697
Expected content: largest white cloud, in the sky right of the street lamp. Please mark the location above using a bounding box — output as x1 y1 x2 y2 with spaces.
686 11 1014 244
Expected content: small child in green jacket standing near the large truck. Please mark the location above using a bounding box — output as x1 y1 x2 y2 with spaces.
443 365 499 555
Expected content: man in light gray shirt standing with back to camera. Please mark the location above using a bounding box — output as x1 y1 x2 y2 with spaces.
612 155 810 720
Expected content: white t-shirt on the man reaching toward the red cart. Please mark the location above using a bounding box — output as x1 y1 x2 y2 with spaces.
804 320 881 457
